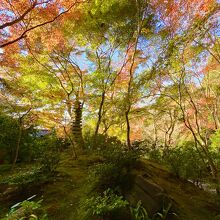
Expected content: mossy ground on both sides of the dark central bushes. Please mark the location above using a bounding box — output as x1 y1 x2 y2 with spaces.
0 152 220 220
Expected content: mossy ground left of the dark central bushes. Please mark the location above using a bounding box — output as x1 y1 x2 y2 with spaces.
0 151 99 220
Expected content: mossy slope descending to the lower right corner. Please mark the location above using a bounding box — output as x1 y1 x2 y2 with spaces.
136 160 220 220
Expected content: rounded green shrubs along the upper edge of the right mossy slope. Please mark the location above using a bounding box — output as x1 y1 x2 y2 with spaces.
144 141 209 182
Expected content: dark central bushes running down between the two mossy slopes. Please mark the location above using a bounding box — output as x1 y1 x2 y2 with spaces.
80 138 140 219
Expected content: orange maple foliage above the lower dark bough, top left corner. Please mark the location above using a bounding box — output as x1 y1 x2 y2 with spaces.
0 0 85 48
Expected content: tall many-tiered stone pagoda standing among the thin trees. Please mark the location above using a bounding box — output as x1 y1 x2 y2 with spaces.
72 100 84 149
